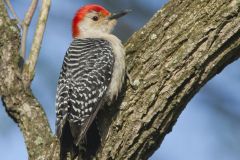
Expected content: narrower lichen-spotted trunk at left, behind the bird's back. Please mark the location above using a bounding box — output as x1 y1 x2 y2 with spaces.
0 0 59 160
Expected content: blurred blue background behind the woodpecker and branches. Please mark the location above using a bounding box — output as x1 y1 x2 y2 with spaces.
0 0 240 160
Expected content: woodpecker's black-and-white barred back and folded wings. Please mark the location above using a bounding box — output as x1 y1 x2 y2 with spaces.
56 38 114 145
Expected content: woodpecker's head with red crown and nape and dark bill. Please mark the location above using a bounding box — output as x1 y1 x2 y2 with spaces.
72 4 129 38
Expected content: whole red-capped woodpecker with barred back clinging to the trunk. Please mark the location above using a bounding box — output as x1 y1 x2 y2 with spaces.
56 4 128 159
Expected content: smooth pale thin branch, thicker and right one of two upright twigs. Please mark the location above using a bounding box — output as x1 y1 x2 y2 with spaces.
23 0 51 86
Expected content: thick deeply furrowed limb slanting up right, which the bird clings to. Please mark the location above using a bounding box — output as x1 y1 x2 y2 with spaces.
94 0 240 160
